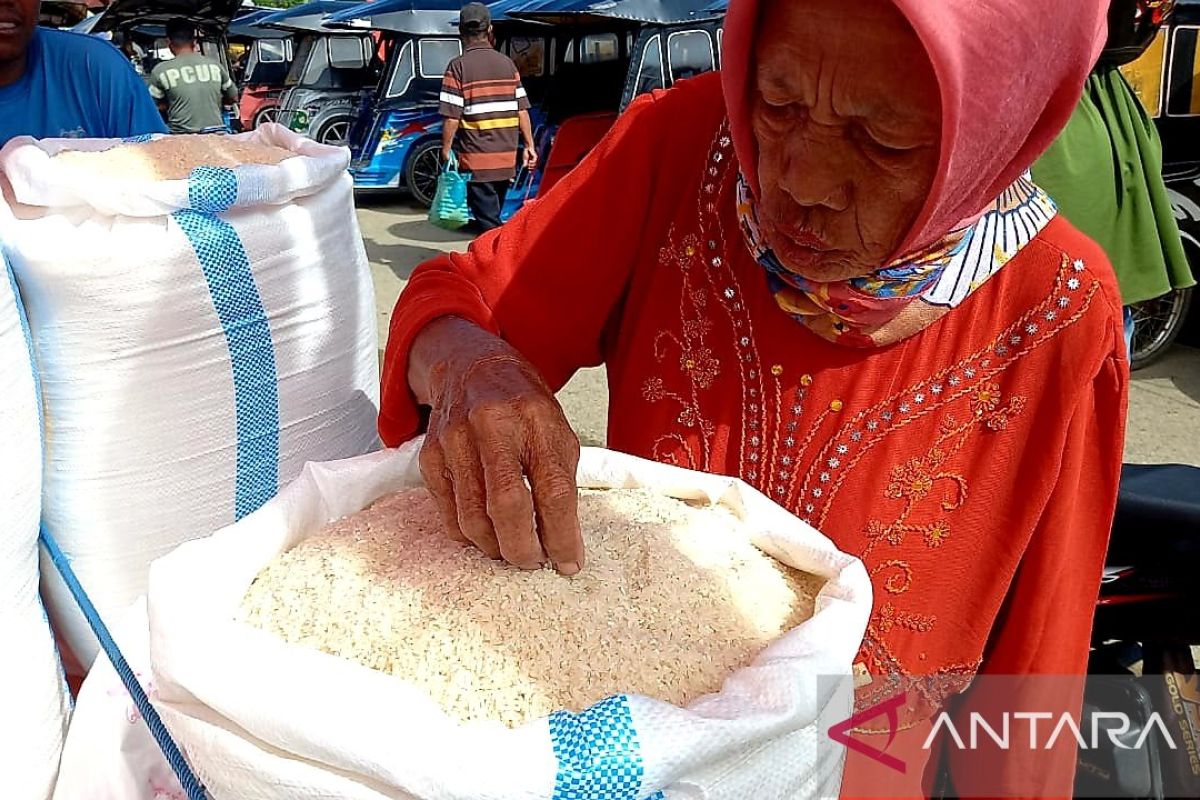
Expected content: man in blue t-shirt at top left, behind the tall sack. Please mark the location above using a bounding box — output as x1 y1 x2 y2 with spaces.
0 0 167 145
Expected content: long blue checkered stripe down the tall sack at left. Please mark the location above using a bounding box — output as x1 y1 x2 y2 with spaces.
172 169 280 519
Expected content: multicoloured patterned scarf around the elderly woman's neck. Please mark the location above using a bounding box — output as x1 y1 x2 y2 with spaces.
737 174 1057 348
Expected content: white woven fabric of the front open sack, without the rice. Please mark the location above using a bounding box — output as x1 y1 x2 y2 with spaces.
149 441 871 800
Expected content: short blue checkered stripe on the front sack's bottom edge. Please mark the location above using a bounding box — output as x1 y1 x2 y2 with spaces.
550 694 665 800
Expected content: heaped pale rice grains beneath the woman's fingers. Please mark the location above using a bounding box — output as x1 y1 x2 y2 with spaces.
241 489 823 727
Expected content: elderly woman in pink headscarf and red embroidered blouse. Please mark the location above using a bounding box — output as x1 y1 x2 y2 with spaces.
380 0 1128 796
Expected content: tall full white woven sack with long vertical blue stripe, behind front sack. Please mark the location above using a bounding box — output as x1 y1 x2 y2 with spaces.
0 126 378 668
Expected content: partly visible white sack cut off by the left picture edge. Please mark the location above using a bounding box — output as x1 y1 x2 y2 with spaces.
0 258 70 800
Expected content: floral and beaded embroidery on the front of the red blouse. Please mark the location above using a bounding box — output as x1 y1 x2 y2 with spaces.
642 120 1099 712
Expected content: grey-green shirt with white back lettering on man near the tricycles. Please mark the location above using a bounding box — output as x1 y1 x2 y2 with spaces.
149 53 238 133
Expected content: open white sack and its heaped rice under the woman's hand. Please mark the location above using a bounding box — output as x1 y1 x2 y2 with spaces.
149 441 871 800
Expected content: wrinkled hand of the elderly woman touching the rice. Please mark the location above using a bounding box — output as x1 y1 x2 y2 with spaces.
409 318 583 575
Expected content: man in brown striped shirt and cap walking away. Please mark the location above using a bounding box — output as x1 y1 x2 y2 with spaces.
440 2 538 231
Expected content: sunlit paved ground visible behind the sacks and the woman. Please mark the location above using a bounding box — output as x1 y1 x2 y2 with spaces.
359 197 1200 465
